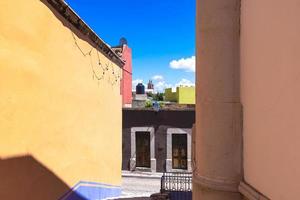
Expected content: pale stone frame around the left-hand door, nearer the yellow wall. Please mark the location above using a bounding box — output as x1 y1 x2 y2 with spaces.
130 126 156 172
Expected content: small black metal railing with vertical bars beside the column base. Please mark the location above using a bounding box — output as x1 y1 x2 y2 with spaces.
160 172 192 192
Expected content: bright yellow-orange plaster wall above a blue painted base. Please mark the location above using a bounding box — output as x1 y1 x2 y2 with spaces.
0 0 122 199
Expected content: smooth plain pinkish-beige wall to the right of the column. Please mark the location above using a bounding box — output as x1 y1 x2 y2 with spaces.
241 0 300 200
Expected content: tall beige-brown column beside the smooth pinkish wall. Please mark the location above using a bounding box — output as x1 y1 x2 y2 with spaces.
193 0 242 200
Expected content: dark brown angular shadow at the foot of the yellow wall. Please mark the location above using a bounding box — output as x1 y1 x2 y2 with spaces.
0 155 86 200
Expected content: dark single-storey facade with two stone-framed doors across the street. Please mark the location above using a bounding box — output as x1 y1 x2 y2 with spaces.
122 108 195 172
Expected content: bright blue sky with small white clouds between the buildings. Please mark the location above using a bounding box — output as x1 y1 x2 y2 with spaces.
67 0 195 90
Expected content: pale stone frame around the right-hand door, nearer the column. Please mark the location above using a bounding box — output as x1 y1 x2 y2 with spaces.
166 128 192 172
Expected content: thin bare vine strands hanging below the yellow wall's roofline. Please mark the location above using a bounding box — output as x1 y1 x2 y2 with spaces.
70 29 121 86
